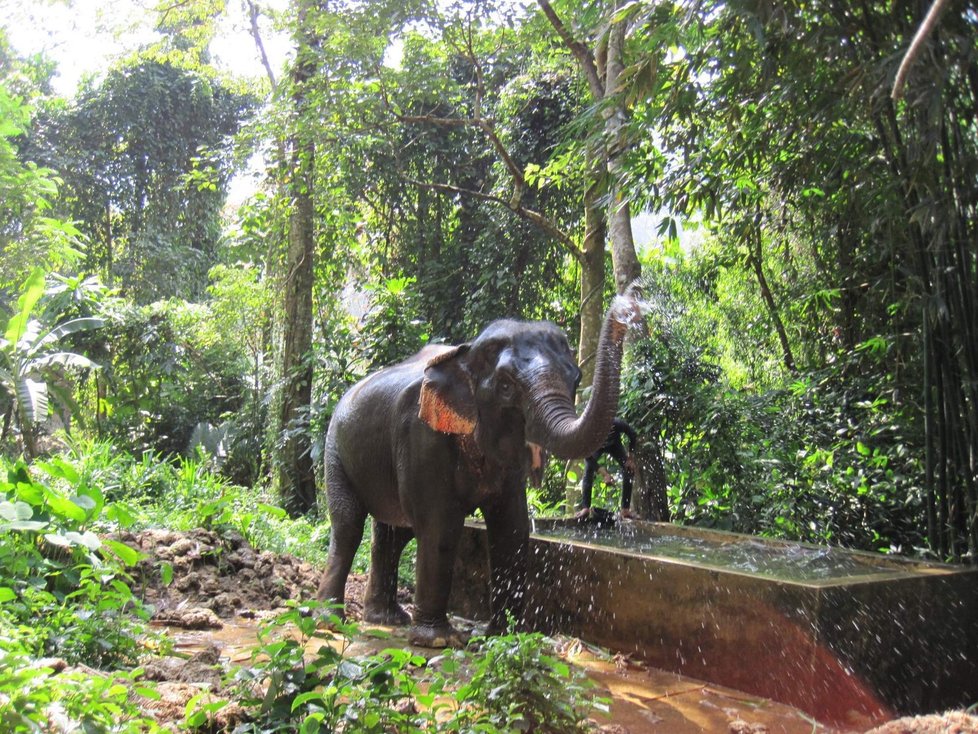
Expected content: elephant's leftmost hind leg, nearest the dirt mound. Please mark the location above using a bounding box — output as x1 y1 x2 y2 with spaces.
318 458 367 606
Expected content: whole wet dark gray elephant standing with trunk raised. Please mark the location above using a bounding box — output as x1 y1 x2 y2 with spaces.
319 296 640 647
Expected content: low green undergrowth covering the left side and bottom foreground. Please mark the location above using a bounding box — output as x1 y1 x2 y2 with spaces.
0 443 604 734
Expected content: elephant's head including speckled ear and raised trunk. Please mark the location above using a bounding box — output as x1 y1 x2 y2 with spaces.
420 294 641 474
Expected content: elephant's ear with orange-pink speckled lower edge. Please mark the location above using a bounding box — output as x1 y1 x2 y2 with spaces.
418 344 476 433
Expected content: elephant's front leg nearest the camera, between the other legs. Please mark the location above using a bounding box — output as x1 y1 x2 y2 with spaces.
408 513 465 647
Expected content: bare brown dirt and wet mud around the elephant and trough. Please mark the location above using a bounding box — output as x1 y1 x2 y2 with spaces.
103 530 978 734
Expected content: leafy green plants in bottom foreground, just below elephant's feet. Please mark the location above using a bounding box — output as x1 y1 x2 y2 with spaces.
203 604 607 734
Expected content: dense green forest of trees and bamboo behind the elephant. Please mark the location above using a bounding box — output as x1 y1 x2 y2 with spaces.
0 0 978 562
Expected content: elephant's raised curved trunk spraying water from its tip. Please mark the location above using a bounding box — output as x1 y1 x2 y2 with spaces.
536 291 642 459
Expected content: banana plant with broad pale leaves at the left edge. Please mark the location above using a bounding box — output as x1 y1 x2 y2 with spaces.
0 269 105 459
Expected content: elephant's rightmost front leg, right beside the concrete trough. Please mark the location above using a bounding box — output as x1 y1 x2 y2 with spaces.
482 484 530 634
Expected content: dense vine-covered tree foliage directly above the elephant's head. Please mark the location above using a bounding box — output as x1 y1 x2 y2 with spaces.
344 17 581 342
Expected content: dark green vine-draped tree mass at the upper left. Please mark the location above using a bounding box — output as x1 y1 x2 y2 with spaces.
28 59 253 303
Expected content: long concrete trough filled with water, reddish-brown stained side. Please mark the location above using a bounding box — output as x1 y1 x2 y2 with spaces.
452 519 978 727
